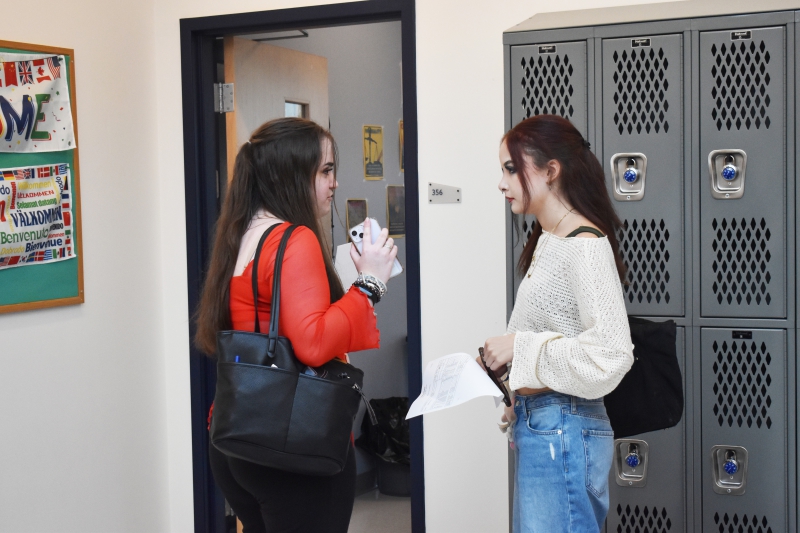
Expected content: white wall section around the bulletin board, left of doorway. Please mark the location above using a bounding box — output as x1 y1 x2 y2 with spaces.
0 0 167 533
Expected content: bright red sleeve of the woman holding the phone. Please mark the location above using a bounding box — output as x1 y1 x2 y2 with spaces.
270 227 380 366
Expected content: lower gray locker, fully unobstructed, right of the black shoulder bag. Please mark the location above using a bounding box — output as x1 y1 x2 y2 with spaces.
701 328 788 533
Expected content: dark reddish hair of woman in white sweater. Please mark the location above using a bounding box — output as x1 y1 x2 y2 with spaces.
503 115 627 282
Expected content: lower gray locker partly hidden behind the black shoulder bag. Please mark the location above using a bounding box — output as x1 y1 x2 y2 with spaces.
606 327 686 533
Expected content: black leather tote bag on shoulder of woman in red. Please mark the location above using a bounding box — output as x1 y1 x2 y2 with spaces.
210 225 374 476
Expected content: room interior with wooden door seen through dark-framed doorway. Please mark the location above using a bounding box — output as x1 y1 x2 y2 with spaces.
216 22 411 533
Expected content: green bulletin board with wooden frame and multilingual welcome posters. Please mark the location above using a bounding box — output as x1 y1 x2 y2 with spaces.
0 40 84 313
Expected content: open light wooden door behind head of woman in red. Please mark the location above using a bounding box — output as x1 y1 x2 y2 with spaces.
224 36 332 250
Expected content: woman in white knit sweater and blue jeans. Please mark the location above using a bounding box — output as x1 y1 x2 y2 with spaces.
484 115 633 533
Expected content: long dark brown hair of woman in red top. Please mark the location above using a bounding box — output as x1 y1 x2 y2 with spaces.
194 118 344 355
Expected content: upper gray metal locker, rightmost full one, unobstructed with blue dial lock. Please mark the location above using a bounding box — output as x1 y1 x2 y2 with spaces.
698 27 787 318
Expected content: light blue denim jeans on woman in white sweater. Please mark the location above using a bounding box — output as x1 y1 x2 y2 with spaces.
513 391 614 533
